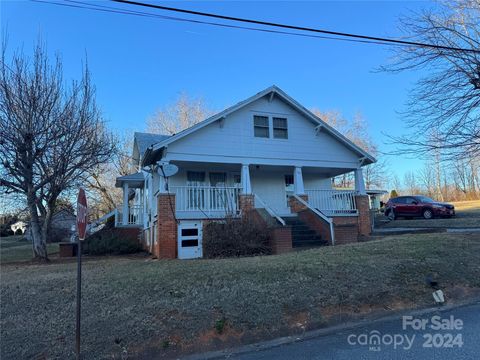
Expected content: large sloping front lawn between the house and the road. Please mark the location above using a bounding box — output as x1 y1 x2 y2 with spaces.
0 233 480 359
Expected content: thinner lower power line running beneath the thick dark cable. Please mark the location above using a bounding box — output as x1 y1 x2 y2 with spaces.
30 0 401 45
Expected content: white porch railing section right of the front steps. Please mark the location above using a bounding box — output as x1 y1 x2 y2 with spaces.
305 189 358 216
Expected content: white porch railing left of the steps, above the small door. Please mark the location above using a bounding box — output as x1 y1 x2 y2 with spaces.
170 186 240 215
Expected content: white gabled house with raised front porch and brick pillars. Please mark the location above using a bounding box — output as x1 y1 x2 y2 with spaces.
116 86 375 258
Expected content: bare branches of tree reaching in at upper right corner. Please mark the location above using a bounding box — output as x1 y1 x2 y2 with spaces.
382 0 480 160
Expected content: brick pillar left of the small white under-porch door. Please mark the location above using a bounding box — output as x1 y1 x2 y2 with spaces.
153 194 178 259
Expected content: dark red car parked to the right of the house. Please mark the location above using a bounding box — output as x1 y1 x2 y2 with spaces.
385 195 455 220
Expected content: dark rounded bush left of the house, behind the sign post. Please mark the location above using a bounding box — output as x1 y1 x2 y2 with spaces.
83 229 141 255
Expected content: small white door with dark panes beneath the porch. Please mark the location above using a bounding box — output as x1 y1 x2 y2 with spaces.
178 221 203 259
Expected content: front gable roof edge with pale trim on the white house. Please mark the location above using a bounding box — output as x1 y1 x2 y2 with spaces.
142 85 376 165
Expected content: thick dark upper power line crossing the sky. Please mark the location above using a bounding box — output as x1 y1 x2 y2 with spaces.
111 0 480 53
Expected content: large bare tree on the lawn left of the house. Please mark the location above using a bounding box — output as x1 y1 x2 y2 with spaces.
0 44 114 261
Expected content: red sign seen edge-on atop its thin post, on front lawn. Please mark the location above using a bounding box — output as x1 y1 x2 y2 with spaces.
75 188 87 359
